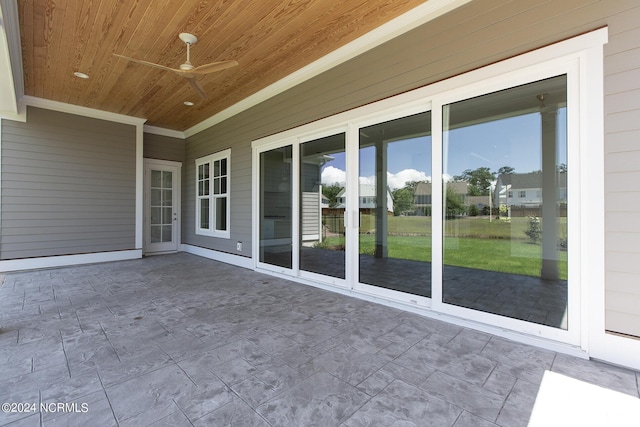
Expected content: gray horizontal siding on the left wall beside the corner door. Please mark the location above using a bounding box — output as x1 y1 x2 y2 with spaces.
0 107 136 260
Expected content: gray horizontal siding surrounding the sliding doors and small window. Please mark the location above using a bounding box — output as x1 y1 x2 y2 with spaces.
183 0 640 336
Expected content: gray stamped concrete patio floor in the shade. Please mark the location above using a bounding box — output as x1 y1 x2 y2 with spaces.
0 253 640 427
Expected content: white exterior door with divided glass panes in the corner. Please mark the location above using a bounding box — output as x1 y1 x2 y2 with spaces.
144 159 181 254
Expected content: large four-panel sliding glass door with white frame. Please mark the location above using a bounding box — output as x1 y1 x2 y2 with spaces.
254 34 594 345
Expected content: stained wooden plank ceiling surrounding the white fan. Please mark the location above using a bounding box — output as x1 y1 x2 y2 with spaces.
18 0 426 130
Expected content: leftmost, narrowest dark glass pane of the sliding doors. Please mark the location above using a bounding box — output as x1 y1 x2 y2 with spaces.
259 145 293 268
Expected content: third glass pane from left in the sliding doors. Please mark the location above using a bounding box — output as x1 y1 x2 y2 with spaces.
358 112 431 297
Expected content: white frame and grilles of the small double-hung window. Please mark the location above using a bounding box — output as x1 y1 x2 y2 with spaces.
195 148 231 239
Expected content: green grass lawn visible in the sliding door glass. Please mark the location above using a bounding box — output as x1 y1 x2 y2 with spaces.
325 215 567 279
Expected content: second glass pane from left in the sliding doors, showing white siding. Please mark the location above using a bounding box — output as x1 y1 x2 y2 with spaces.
300 133 346 279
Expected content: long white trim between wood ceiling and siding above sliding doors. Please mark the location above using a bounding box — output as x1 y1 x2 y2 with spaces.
184 0 471 137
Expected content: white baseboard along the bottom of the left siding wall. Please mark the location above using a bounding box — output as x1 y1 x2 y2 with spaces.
0 249 142 273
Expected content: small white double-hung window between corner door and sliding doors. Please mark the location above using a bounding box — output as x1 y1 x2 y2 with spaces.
196 149 231 239
